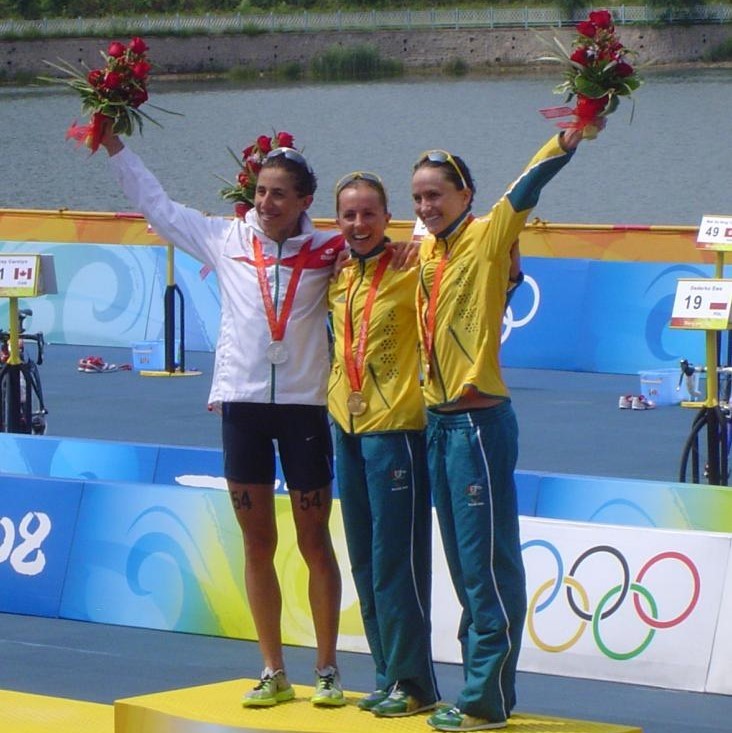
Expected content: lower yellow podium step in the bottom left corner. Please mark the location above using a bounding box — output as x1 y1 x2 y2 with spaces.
0 690 114 733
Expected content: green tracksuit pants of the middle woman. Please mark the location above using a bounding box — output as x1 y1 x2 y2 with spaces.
335 426 439 704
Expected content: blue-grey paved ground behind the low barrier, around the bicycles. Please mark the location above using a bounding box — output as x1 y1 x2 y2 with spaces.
41 345 693 481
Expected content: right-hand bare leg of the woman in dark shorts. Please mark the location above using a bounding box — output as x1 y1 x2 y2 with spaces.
290 484 341 669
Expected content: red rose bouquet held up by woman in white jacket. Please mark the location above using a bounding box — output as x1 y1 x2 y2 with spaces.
42 37 173 153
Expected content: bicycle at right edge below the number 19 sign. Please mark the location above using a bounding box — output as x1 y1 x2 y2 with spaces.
679 359 732 486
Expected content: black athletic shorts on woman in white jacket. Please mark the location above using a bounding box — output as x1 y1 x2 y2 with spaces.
221 402 333 491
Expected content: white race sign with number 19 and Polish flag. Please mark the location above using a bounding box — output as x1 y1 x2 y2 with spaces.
671 279 732 331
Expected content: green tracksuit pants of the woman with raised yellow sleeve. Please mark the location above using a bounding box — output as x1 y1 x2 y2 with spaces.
427 401 526 722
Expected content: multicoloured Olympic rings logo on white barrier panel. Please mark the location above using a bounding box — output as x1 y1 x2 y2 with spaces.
521 539 701 661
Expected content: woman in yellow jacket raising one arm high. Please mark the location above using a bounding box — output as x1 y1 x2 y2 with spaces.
412 131 582 731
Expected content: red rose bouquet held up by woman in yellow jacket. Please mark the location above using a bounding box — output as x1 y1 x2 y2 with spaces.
540 10 641 138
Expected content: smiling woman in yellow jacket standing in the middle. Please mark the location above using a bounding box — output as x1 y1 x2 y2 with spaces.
328 171 439 717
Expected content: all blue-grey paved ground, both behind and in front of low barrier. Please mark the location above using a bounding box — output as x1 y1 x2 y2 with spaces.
0 346 732 733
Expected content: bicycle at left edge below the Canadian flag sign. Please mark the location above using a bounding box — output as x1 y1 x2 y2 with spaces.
0 308 48 435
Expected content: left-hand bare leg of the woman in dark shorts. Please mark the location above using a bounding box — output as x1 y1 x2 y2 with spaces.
228 481 285 670
